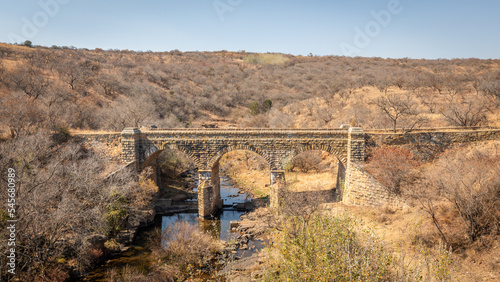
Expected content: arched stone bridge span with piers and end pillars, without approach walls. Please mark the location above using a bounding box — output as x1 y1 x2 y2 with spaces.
121 128 365 217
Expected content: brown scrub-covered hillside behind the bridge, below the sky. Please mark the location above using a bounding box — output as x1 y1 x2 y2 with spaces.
0 44 500 135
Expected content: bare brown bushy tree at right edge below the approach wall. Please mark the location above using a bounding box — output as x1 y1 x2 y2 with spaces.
427 142 500 241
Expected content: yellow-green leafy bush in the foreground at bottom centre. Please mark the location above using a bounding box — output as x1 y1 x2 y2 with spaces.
266 213 391 281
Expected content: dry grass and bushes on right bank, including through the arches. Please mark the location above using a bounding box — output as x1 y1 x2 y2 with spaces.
227 141 500 281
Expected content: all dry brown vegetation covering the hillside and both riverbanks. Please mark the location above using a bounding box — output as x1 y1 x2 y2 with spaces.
0 44 500 281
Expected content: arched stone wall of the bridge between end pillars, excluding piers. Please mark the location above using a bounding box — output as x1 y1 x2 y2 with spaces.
140 129 348 170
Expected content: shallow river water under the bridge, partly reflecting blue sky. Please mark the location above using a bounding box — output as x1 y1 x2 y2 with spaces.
82 177 253 281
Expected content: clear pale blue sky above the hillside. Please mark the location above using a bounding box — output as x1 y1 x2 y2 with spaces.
0 0 500 59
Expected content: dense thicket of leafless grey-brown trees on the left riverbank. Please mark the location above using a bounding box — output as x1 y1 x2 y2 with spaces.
0 133 155 281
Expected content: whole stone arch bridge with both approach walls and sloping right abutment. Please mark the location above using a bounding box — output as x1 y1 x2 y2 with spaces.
75 126 500 217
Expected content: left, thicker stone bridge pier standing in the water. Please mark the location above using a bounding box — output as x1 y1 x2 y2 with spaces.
198 163 223 218
